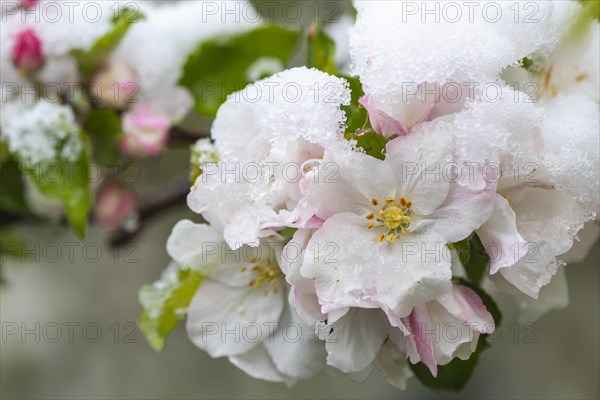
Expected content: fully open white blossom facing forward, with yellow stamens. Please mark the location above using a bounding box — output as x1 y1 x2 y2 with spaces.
292 130 493 326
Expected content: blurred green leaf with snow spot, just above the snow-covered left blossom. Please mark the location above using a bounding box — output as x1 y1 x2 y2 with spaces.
179 25 300 117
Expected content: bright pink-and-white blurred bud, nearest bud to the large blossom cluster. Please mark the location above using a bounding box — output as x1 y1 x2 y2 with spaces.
119 105 171 157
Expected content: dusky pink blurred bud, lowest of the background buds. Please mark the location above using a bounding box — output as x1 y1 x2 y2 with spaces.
94 182 137 231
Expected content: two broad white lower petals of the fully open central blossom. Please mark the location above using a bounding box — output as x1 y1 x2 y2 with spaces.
301 213 451 317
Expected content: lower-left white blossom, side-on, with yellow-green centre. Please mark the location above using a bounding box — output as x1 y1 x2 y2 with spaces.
167 220 325 383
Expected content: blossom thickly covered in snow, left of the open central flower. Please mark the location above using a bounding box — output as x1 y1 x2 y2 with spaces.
188 68 350 248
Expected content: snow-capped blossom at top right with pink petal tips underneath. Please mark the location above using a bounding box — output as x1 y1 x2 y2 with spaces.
350 1 576 137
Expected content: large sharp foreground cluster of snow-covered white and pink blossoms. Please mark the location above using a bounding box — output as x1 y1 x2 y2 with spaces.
156 1 600 388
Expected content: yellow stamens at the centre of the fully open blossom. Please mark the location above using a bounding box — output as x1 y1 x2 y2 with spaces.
366 197 412 243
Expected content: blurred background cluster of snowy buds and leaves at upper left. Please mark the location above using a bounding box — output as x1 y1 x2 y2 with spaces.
0 0 262 234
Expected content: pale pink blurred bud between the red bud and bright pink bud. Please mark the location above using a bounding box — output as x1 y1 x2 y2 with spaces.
94 62 138 109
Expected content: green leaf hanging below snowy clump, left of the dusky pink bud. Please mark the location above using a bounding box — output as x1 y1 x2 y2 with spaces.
19 132 92 237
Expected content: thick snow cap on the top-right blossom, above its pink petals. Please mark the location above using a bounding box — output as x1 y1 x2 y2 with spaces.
350 1 576 97
